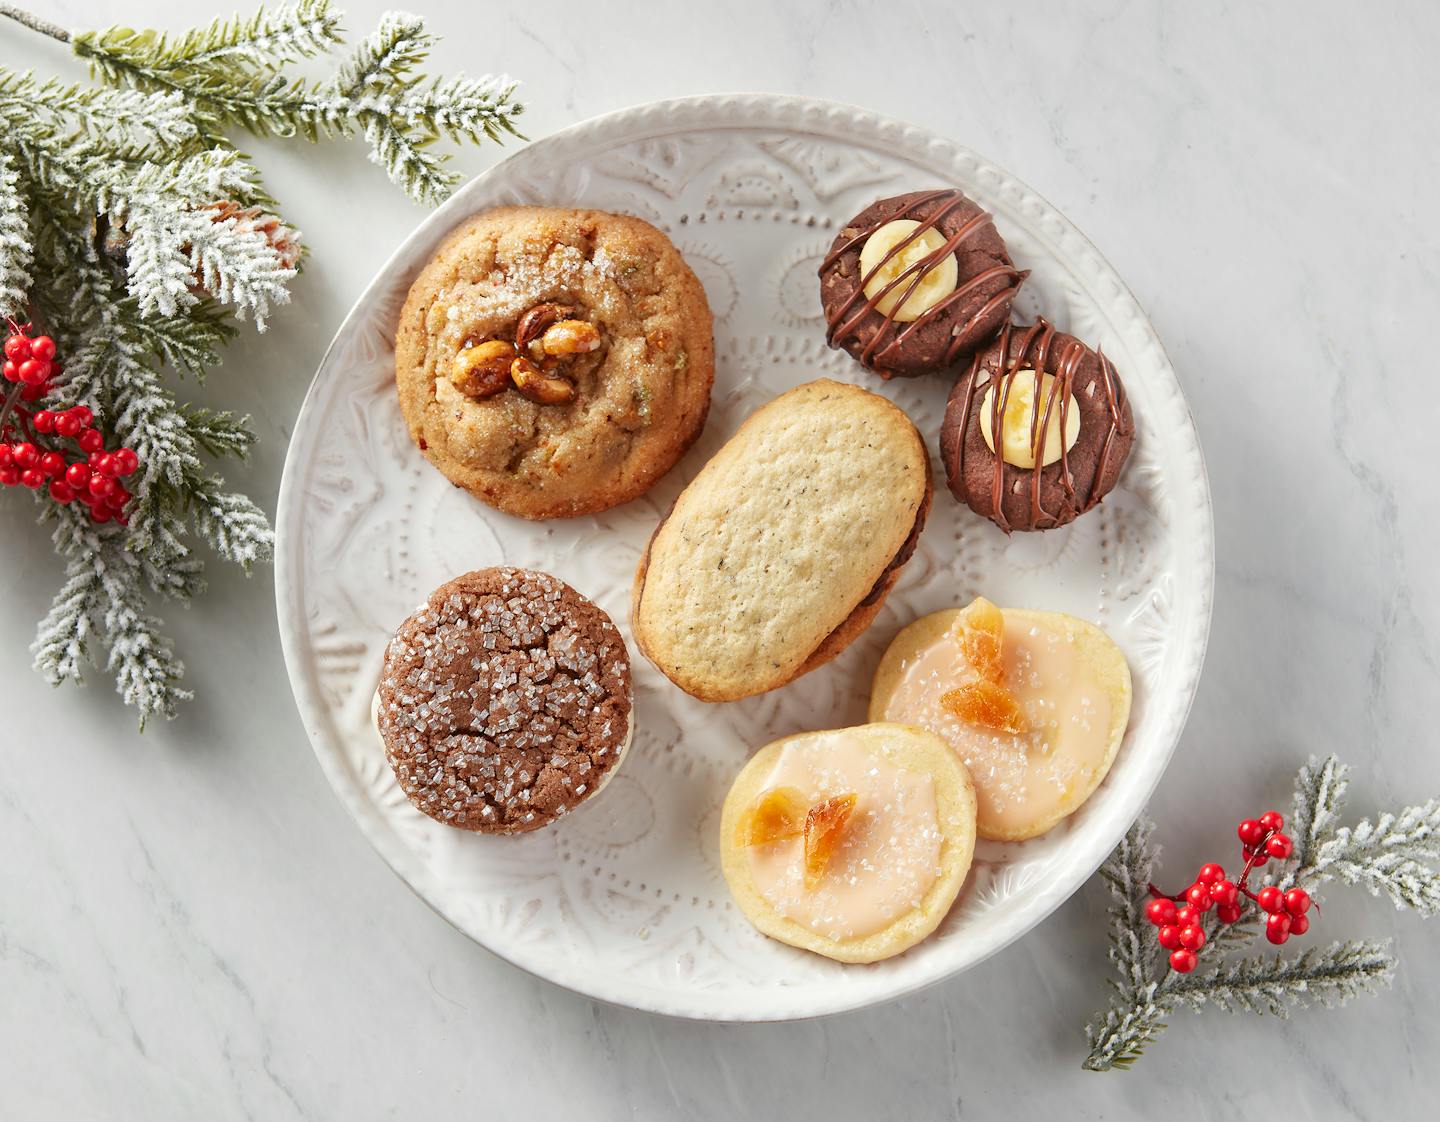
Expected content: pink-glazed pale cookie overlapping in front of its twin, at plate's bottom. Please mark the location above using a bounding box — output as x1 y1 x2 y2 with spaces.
720 724 975 962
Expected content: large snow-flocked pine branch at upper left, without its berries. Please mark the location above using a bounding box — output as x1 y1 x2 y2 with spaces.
0 0 521 723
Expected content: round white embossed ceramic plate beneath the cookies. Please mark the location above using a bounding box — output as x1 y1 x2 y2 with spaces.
276 95 1214 1020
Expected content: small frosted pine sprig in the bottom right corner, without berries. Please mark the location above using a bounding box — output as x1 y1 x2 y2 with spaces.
1083 756 1440 1072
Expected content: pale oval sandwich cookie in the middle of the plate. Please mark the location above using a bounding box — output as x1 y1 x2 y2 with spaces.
631 379 930 701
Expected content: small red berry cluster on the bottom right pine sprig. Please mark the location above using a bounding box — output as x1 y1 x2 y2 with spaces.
1145 811 1310 974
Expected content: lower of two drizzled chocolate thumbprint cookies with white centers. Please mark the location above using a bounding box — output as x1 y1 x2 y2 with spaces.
940 320 1135 533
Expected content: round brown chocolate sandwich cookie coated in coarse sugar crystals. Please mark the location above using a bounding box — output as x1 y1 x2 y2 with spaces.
376 569 632 834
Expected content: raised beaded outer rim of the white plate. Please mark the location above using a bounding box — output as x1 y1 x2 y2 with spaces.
275 94 1214 1021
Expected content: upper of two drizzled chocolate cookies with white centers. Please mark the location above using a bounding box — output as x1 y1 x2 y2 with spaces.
819 190 1027 377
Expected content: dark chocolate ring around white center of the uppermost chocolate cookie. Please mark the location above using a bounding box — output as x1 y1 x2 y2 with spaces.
819 190 1025 377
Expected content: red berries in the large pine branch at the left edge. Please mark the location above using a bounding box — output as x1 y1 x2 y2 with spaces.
0 323 140 524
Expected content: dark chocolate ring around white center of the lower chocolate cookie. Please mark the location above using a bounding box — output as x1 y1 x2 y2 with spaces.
940 320 1135 531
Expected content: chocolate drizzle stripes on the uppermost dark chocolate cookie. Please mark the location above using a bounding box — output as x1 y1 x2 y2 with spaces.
819 189 1030 377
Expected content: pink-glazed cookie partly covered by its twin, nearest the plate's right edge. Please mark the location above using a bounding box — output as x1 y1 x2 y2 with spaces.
870 601 1130 841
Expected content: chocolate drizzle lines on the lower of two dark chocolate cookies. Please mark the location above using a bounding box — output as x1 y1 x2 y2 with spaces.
952 320 1133 533
